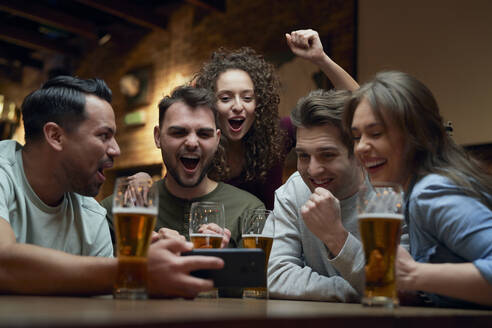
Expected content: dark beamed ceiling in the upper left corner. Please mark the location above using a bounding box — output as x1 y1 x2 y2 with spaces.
0 0 225 80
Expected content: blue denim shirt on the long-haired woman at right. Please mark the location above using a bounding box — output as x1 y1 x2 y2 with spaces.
405 174 492 306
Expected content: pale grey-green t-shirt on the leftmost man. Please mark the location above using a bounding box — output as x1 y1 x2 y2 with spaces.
0 140 113 257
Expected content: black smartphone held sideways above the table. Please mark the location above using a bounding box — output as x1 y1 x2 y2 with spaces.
181 248 266 288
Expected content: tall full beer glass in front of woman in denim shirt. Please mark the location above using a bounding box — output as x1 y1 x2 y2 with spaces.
357 183 403 308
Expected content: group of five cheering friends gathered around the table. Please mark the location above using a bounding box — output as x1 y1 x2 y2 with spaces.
0 30 492 307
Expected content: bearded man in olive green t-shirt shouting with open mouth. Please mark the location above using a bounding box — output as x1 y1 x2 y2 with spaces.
103 86 264 247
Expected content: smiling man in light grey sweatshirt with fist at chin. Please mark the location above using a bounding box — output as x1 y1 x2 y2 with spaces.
268 90 365 302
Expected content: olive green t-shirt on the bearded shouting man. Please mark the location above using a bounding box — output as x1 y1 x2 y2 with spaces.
102 179 265 248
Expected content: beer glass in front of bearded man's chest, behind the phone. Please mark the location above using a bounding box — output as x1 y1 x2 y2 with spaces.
190 202 225 298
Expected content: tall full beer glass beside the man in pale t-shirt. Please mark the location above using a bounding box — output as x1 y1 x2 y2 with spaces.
113 177 159 299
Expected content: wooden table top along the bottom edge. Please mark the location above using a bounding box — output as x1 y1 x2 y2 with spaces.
0 296 492 328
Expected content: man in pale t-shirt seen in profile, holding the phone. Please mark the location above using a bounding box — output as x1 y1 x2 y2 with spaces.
0 76 223 297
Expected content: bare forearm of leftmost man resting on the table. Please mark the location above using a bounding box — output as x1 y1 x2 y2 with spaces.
0 243 117 295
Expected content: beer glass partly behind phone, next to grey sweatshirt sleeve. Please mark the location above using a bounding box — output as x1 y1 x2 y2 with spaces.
242 209 275 298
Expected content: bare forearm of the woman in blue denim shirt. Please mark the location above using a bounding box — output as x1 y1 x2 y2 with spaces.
413 263 492 305
